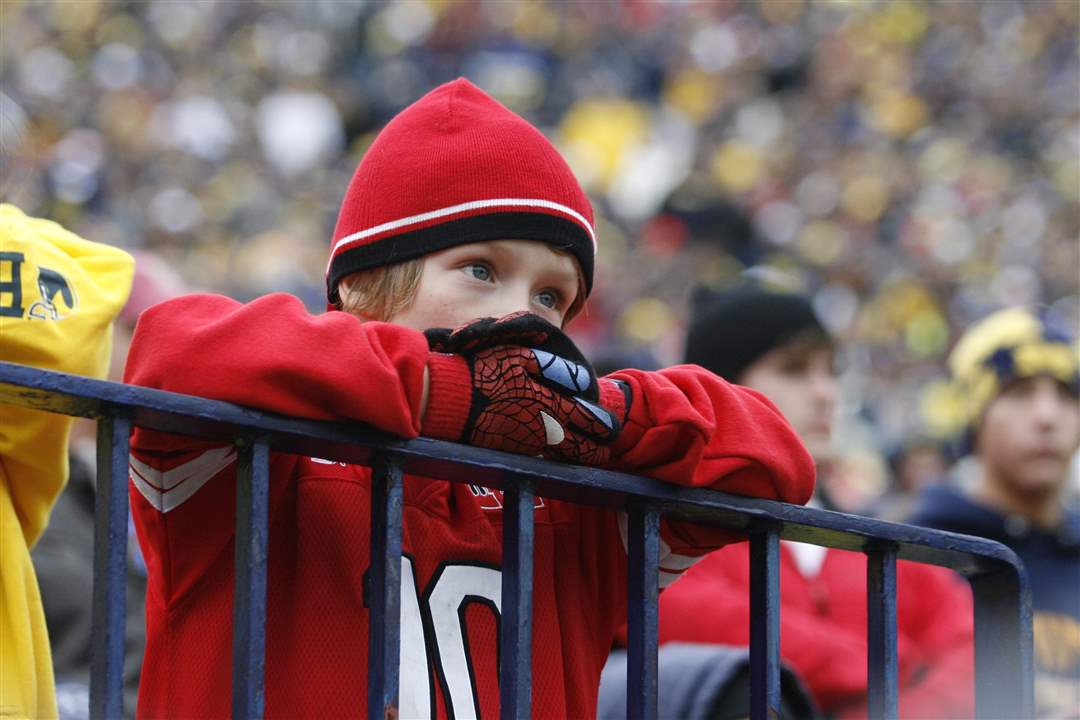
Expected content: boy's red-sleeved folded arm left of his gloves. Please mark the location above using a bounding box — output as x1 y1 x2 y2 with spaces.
124 293 428 437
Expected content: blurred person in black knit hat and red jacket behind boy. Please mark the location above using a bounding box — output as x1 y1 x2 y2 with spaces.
660 283 974 719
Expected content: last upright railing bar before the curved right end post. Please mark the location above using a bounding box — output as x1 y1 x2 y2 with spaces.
866 543 898 720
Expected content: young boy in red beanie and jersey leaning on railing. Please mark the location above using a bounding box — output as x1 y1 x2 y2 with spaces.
126 80 813 718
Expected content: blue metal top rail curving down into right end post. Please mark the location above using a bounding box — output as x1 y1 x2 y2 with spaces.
0 363 1031 717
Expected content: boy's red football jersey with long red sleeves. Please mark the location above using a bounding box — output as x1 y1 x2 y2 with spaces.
126 295 813 718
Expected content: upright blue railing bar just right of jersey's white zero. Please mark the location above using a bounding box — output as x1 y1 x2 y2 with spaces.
499 483 536 720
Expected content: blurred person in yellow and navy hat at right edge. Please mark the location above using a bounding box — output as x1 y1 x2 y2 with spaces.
910 308 1080 718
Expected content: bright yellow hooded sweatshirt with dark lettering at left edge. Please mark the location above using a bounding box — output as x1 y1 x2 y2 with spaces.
0 204 135 718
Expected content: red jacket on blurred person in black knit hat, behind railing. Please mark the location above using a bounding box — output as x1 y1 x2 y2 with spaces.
660 543 974 719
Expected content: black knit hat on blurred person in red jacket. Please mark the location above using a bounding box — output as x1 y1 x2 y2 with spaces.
685 283 829 382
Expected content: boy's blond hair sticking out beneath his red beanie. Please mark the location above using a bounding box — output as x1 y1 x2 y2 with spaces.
337 250 585 326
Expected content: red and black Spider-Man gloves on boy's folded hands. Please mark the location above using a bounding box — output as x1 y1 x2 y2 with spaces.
421 313 620 465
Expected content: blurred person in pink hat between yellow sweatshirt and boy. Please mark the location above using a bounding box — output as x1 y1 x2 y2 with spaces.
31 252 186 720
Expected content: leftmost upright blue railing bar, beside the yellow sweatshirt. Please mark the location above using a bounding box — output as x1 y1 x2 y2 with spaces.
90 410 132 719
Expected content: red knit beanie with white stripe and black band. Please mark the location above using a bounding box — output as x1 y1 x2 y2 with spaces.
326 78 596 305
